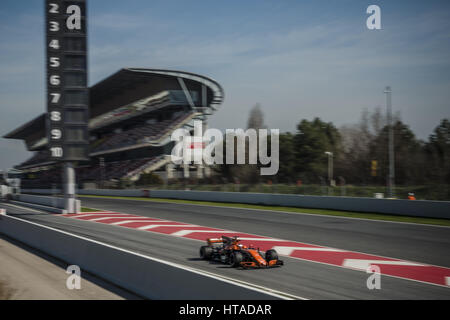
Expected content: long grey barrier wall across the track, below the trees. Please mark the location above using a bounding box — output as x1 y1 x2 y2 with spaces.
22 189 450 219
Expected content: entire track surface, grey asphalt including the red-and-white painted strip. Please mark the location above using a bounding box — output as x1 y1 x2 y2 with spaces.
1 198 450 299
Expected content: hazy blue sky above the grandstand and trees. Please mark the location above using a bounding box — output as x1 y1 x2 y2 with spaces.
0 0 450 168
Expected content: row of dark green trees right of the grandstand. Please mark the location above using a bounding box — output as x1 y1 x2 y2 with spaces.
217 105 450 186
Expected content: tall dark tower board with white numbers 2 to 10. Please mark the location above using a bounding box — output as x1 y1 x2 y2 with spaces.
45 0 89 161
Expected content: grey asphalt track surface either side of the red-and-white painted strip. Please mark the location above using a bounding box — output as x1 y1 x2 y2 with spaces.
2 198 450 299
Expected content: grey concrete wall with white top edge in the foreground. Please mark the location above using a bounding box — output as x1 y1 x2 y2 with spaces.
0 215 286 300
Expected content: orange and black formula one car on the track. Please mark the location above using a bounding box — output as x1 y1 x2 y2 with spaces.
200 236 283 268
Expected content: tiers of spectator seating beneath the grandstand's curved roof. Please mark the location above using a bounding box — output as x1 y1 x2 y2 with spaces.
17 92 204 188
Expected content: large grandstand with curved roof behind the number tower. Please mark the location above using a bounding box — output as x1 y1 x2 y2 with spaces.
4 68 224 188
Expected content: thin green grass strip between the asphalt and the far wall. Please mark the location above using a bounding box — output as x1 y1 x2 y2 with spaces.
79 195 450 226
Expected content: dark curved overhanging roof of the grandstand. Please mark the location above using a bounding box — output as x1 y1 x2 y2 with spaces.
3 68 224 141
